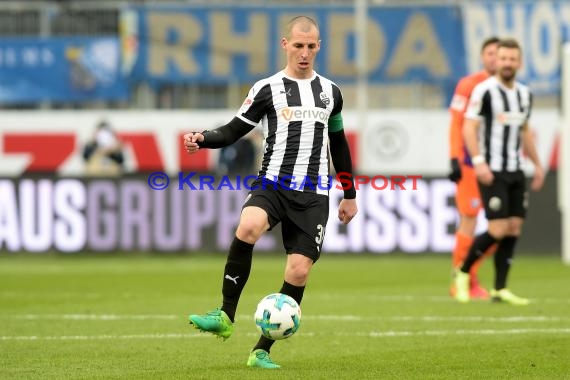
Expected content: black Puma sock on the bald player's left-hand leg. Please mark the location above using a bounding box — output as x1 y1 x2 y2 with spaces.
222 237 253 322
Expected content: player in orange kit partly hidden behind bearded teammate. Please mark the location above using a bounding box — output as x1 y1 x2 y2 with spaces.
449 37 499 299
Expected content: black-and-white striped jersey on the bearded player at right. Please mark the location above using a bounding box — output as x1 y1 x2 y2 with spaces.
465 76 532 172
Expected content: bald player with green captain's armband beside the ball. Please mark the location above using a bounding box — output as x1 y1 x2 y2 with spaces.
184 16 357 369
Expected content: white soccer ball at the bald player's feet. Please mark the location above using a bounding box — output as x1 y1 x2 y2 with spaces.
254 293 301 340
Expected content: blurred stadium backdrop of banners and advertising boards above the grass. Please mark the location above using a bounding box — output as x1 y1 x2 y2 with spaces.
0 1 560 255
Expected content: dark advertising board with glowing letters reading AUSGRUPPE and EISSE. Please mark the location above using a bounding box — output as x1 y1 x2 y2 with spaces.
0 177 470 253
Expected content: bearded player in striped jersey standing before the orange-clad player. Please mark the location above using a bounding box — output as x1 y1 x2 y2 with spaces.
455 39 544 305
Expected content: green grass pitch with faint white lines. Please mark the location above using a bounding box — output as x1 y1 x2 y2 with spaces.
0 254 570 380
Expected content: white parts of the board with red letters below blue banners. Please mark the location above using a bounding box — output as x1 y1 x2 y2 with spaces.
0 110 560 177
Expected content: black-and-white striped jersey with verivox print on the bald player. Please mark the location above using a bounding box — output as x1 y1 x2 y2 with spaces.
236 71 343 195
